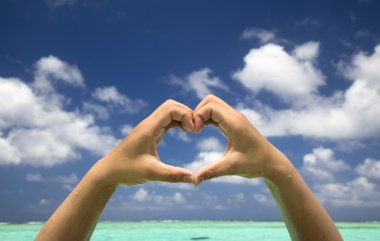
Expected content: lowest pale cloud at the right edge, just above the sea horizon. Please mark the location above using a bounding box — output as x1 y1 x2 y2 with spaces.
315 177 380 207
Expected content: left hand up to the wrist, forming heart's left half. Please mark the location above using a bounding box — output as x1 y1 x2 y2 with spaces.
98 100 194 186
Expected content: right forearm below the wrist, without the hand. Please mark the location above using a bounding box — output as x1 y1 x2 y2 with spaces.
265 150 342 241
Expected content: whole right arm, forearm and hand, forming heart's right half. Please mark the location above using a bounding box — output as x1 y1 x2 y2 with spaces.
193 95 342 241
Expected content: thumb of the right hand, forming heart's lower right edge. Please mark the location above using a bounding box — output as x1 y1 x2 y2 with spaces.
194 156 232 186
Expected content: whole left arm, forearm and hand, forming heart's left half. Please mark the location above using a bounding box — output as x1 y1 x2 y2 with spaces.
36 100 194 241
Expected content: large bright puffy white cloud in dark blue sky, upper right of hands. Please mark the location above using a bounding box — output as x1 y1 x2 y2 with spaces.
233 42 325 103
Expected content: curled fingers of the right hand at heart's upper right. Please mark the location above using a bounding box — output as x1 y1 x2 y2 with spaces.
193 102 229 134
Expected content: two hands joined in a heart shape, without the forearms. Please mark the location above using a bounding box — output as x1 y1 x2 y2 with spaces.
105 95 271 186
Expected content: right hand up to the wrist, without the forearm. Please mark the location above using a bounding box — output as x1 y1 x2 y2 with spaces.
193 95 278 185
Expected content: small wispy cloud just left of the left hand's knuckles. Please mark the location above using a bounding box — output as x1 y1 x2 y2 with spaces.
92 86 147 113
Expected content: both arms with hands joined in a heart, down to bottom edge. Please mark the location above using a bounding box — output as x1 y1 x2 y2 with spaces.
36 95 343 241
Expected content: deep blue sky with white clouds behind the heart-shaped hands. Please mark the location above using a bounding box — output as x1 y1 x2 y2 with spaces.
0 0 380 222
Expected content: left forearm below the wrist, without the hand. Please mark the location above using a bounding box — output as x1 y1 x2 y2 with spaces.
36 158 116 241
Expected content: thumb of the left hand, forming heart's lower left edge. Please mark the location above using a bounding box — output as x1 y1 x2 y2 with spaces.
150 162 194 183
